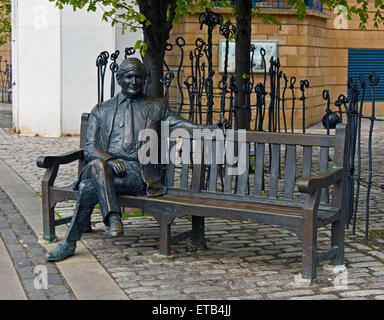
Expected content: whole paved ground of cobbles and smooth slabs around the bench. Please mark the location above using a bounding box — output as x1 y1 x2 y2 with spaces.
0 104 384 300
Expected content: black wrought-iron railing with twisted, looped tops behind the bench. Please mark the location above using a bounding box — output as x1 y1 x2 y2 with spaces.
96 10 384 236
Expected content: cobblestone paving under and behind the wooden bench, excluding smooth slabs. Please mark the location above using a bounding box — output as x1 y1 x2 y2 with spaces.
0 118 384 300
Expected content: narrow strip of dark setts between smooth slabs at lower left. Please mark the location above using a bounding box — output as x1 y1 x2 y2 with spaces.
0 189 75 300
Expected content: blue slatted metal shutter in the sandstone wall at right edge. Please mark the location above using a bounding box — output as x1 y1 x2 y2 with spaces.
348 49 384 101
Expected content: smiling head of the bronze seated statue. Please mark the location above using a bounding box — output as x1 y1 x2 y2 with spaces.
116 58 146 97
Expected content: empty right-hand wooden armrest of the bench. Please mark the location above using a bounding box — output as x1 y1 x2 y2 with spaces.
298 167 345 194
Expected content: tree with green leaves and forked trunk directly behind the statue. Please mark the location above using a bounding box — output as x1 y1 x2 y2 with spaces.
49 0 234 96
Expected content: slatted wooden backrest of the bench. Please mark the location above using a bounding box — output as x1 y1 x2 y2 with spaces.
79 113 347 202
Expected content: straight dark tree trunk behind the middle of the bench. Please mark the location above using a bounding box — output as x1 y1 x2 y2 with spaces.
235 0 252 129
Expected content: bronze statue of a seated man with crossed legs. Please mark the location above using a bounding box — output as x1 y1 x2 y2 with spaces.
46 58 225 261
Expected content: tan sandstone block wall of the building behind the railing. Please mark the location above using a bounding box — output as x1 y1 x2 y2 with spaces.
166 4 384 128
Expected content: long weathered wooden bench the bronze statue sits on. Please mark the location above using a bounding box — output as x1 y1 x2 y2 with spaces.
37 114 348 280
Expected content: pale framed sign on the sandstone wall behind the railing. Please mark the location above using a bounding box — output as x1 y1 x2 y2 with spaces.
219 39 277 73
